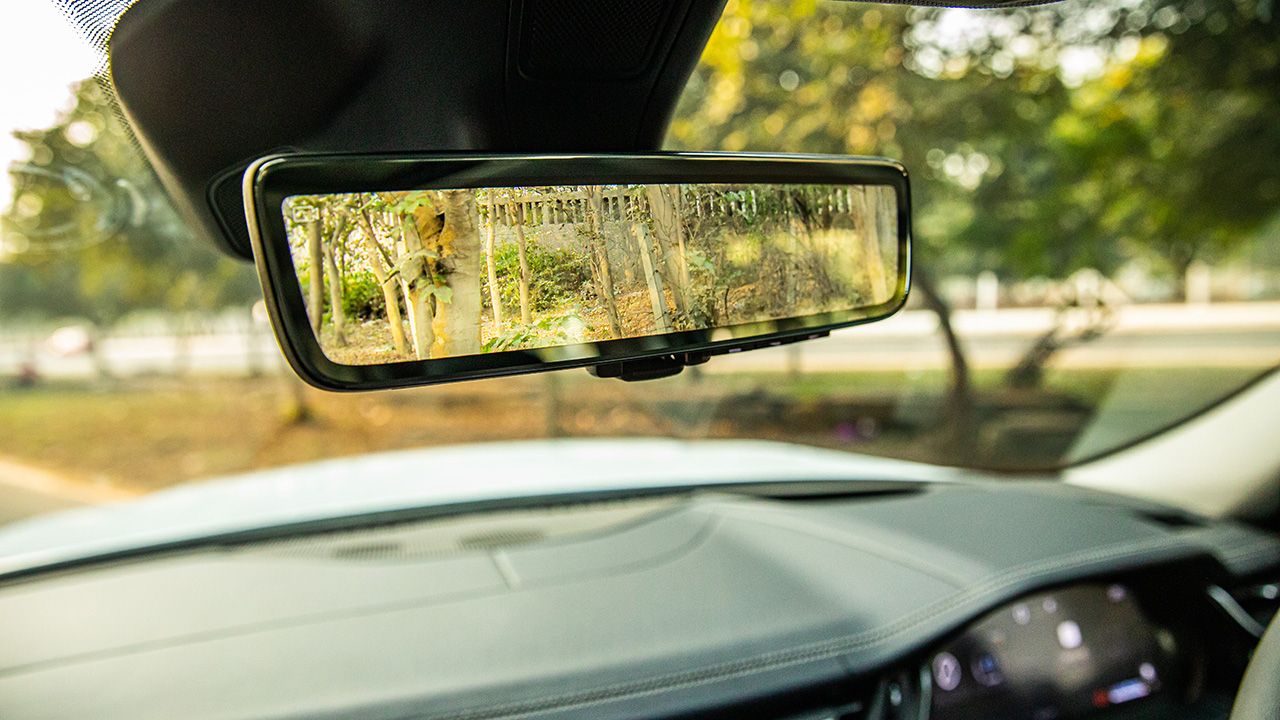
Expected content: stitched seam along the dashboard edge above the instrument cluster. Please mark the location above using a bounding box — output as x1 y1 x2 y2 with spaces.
420 536 1204 720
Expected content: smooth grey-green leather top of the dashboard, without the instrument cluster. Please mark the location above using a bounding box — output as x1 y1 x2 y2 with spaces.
0 482 1280 720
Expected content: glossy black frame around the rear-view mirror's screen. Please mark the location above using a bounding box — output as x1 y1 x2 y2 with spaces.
243 152 911 391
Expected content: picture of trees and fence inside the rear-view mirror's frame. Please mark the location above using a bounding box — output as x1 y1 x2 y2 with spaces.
283 184 900 365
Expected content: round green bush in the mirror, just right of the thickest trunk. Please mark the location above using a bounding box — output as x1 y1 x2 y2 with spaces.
483 238 591 311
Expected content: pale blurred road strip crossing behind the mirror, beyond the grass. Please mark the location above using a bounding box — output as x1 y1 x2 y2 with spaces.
0 302 1280 378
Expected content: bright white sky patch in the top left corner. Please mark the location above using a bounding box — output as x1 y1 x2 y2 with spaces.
0 0 99 210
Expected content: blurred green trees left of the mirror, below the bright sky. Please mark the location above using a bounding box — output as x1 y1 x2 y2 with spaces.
0 79 261 325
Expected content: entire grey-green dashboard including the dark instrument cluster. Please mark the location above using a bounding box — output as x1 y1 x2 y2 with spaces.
0 480 1280 720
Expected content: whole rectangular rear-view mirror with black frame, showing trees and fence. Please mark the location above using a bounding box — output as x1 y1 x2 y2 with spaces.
244 154 910 389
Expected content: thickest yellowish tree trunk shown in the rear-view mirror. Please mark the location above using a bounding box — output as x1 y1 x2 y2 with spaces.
435 190 484 357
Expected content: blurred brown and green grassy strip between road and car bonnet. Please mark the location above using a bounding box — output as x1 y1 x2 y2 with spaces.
0 368 1265 492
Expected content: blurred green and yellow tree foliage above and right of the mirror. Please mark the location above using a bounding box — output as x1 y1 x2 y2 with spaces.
668 0 1280 284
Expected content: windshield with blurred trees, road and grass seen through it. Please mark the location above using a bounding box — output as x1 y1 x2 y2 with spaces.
0 0 1280 521
